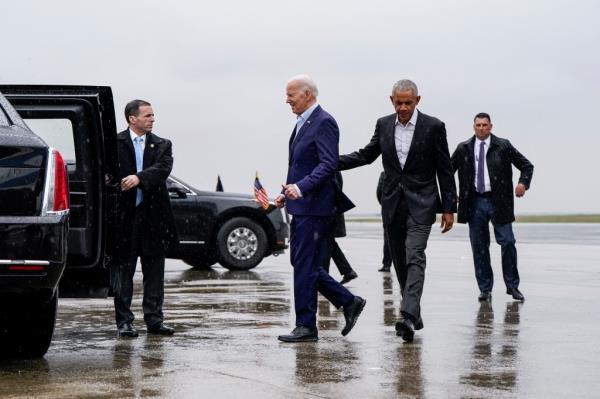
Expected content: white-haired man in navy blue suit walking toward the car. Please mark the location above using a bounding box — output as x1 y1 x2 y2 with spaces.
275 75 367 342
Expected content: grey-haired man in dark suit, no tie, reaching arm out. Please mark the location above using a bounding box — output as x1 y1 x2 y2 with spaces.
339 80 456 341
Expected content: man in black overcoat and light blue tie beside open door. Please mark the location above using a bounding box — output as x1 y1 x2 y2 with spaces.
113 100 176 337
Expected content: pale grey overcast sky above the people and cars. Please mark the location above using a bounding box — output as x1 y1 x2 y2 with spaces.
0 0 600 213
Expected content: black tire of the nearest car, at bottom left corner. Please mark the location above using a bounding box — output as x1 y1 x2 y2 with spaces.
2 290 58 358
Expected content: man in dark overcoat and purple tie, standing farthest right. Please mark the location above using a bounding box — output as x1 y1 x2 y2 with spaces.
452 112 533 301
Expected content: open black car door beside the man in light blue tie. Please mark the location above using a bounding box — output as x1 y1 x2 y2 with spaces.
0 85 120 297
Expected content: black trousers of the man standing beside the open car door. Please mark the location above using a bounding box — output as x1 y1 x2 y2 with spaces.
114 205 165 328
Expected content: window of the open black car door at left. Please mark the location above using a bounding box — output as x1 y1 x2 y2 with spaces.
24 118 75 163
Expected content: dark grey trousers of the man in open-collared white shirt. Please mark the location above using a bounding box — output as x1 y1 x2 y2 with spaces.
386 201 431 321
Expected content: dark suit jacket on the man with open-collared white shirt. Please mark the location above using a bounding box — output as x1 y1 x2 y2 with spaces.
338 111 456 226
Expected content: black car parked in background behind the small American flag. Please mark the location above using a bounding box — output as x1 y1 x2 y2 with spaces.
167 176 289 270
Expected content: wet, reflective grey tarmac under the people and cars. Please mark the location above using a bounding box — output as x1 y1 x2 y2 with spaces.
0 223 600 398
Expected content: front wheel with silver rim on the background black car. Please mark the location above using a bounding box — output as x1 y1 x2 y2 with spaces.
217 217 268 270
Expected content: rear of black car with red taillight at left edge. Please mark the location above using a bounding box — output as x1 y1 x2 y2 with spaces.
0 90 69 356
